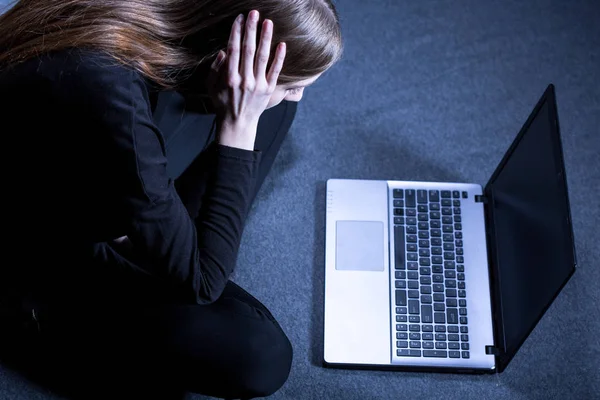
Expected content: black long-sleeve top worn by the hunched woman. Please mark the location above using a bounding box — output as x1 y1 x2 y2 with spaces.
0 49 261 304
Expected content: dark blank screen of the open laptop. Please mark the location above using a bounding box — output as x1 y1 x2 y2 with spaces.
488 98 575 360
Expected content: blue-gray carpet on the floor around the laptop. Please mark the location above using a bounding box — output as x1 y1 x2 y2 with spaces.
0 0 600 400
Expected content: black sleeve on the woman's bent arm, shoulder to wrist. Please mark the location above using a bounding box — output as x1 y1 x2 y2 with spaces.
74 59 261 304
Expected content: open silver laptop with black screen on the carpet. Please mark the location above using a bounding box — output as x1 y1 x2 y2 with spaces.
323 84 577 373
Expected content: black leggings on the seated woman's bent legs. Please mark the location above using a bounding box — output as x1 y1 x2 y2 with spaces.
0 92 297 399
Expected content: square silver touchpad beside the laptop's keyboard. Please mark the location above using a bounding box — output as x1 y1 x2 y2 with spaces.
335 221 384 271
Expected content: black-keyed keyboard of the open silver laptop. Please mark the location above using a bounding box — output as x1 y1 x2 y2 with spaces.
393 189 469 358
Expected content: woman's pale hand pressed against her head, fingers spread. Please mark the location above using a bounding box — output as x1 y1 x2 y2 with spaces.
207 10 285 129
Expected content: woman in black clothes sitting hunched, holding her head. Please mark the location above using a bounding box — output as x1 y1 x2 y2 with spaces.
0 0 342 398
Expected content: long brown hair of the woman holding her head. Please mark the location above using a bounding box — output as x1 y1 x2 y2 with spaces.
0 0 343 89
